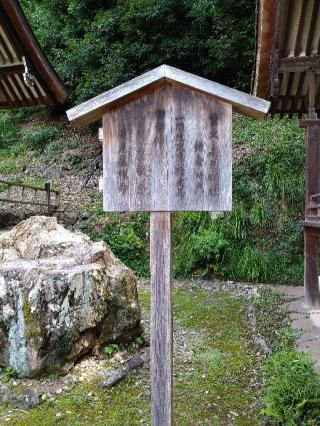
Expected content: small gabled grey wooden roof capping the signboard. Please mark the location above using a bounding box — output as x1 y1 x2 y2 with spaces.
67 65 270 126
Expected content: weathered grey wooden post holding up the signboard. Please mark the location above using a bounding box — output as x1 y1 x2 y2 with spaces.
150 212 172 426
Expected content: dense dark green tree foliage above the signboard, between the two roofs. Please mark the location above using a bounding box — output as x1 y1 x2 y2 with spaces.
21 0 255 102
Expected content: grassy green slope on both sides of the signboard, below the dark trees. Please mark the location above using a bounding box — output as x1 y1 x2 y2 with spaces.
0 109 304 283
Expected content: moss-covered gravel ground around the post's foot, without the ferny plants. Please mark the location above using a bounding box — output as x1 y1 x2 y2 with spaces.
0 280 268 426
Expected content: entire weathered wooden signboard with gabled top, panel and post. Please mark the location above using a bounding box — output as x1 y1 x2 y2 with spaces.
68 65 269 426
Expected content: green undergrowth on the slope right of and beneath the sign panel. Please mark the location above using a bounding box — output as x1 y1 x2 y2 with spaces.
85 118 305 283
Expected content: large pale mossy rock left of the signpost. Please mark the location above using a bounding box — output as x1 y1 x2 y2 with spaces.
0 216 140 376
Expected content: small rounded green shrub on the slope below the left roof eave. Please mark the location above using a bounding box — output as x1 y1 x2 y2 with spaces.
21 124 60 150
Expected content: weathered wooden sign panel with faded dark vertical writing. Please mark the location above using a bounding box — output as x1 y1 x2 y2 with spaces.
103 84 232 211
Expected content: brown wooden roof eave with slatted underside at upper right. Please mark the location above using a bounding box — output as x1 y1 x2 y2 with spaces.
253 0 320 116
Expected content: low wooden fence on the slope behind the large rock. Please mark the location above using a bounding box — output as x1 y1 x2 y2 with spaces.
0 180 60 213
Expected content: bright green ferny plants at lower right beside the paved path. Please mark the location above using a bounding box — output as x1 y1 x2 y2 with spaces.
253 290 320 426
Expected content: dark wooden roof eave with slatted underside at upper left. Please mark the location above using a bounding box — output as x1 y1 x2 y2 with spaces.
0 0 67 108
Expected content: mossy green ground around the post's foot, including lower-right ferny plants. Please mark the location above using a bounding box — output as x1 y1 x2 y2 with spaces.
0 283 320 426
